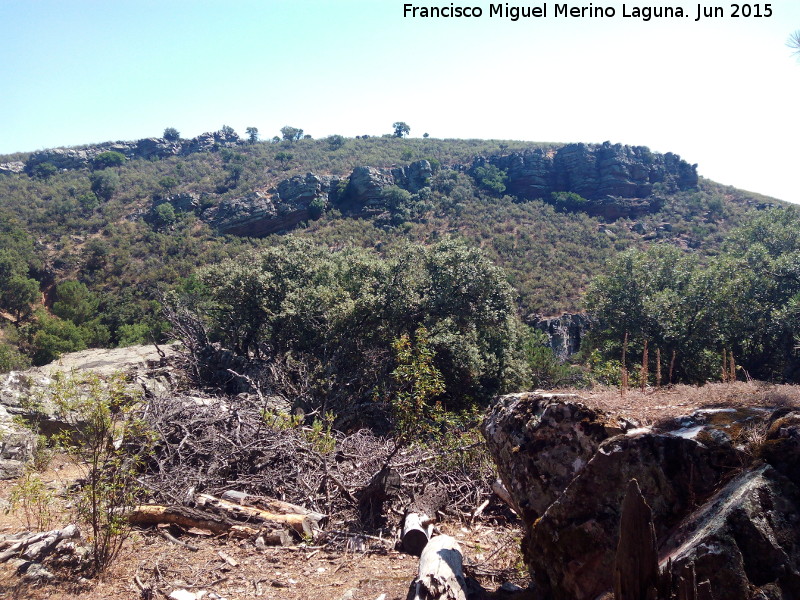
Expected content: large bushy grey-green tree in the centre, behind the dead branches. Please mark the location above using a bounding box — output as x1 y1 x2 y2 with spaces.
168 238 531 424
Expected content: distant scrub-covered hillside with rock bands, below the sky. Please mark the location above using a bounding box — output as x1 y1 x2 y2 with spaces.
0 128 779 362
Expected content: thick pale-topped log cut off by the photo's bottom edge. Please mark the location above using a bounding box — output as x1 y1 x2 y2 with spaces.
406 535 467 600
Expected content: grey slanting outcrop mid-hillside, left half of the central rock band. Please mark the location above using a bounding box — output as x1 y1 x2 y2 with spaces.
211 173 339 237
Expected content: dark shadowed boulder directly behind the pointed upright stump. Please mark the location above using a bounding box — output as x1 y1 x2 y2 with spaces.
524 432 741 600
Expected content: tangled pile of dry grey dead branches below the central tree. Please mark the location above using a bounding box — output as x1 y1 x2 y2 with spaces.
142 395 493 530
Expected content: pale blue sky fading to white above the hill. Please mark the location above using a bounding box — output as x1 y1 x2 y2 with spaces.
0 0 800 202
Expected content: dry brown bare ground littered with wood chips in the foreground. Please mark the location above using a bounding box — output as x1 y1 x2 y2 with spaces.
0 456 527 600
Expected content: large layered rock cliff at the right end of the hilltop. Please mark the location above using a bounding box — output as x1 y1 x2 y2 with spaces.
470 142 698 219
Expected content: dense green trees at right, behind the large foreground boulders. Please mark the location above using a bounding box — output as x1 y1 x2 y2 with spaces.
586 207 800 382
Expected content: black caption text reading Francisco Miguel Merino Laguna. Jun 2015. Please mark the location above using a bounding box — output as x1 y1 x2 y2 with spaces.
403 2 772 21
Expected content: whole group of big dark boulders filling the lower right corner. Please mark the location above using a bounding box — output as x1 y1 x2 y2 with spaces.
484 394 800 600
